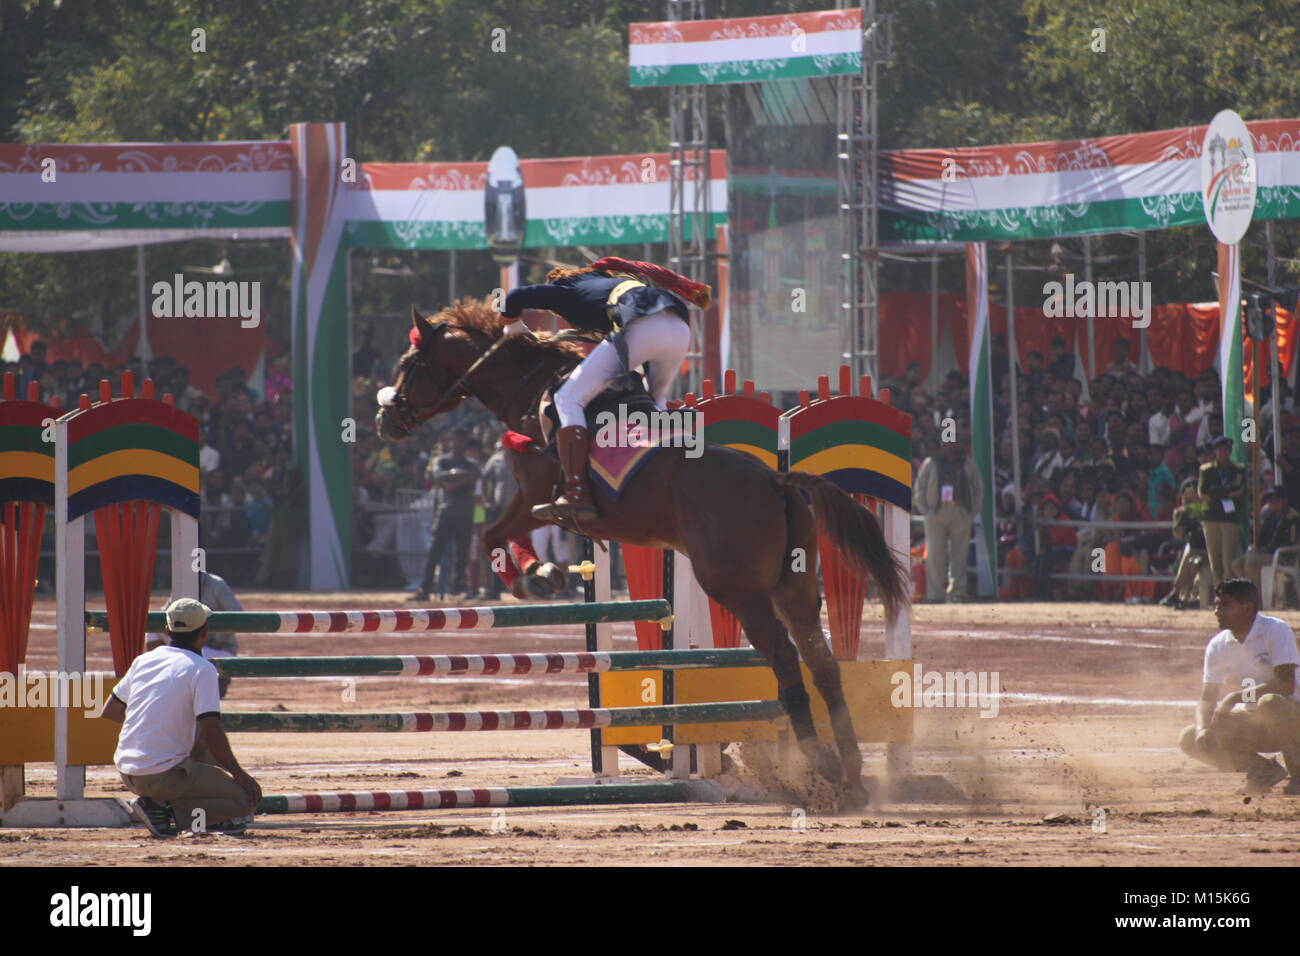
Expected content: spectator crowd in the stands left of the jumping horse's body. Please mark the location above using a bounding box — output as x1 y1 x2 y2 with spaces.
0 329 592 600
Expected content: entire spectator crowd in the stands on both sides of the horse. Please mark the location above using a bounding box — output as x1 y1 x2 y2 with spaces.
12 321 1300 607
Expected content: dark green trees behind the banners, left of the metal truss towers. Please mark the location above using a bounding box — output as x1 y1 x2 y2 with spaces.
0 0 667 333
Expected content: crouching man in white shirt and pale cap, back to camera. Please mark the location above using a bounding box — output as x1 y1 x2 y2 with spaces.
103 597 261 836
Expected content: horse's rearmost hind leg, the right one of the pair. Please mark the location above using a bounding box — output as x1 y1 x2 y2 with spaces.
774 561 868 809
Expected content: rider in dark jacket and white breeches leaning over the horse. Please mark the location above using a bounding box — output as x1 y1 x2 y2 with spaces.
503 256 712 522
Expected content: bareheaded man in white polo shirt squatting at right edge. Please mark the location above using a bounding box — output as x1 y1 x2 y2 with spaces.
1178 578 1300 795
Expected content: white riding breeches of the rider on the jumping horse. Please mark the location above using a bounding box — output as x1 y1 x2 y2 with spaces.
555 312 690 428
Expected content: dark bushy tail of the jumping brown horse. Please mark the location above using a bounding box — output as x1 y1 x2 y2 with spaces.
779 471 911 618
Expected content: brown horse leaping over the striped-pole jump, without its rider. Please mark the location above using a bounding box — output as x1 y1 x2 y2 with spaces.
376 299 910 808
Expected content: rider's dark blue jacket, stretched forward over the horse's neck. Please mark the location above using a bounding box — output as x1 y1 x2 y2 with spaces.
503 272 690 334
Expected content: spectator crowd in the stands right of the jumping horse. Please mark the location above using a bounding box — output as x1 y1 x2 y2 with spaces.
883 336 1300 607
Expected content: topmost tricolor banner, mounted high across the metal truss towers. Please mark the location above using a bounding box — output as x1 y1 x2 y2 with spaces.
628 8 862 86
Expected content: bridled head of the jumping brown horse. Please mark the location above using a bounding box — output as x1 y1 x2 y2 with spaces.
374 306 482 441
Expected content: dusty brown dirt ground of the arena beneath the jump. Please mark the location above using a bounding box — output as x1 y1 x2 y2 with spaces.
0 593 1300 866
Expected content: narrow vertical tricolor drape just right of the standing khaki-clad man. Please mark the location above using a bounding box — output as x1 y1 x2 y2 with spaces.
966 242 997 597
